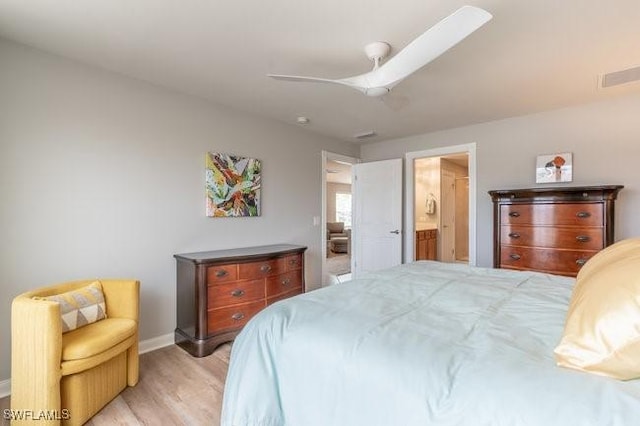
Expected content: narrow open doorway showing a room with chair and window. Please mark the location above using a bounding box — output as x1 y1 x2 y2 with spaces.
322 152 359 286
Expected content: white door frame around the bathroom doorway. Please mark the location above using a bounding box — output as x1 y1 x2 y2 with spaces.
404 143 476 265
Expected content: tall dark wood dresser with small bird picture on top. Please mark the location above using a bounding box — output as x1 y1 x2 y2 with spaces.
489 185 623 276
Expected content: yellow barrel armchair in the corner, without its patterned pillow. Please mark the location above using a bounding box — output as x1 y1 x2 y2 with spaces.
11 280 140 425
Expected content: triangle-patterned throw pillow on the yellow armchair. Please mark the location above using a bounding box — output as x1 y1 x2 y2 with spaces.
38 281 107 333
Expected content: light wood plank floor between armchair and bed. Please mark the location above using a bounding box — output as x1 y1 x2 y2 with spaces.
0 344 231 426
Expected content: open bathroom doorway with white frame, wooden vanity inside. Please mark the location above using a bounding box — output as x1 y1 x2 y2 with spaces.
404 144 476 265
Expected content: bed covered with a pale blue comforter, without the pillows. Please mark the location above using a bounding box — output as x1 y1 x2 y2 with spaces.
221 261 640 426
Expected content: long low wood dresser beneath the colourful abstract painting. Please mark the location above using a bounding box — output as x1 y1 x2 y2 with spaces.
174 244 307 357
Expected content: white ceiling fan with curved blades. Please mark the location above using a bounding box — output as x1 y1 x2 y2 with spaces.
267 6 493 97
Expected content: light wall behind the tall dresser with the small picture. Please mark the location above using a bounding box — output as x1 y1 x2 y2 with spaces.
361 94 640 266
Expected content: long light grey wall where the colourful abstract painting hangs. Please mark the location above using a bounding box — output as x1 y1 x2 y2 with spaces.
0 39 358 381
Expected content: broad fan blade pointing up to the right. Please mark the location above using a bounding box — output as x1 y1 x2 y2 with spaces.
366 6 493 89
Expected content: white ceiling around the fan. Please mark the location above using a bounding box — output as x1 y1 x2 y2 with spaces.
0 0 640 141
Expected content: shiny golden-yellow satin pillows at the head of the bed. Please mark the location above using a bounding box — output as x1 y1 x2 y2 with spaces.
554 238 640 380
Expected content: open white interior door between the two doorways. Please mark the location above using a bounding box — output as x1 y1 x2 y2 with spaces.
351 159 402 278
